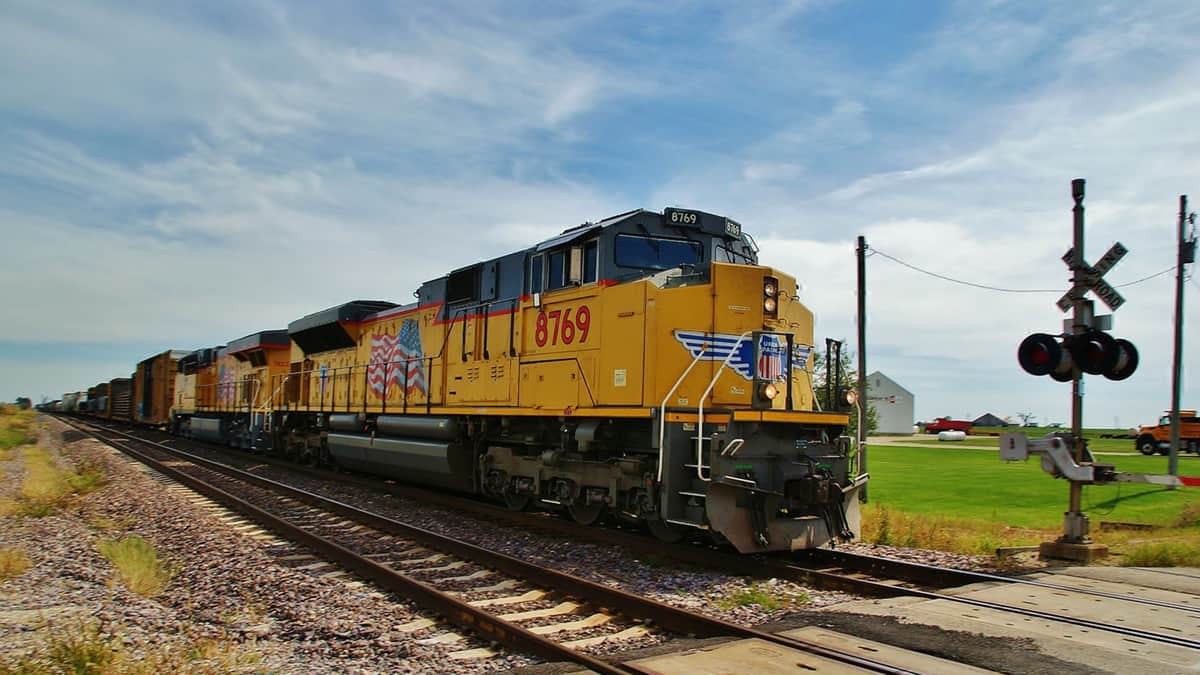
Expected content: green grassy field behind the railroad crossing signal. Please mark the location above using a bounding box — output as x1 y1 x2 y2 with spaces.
864 436 1200 561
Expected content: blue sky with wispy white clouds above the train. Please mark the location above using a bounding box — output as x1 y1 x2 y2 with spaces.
0 0 1200 425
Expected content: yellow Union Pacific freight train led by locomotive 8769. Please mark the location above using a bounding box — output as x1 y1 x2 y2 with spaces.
51 209 866 552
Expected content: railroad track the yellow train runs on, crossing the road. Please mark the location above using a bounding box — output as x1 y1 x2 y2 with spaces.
70 415 1200 650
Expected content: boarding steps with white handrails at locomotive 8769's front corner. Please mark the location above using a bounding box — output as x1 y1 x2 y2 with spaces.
658 330 755 530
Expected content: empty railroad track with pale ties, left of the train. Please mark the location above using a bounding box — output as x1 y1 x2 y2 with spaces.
67 419 911 674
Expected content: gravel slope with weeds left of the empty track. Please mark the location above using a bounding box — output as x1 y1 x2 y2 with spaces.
0 418 518 673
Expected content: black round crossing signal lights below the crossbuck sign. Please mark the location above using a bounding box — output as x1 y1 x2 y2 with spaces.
1016 330 1138 382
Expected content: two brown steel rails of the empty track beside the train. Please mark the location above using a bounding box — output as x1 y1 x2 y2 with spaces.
68 420 911 674
